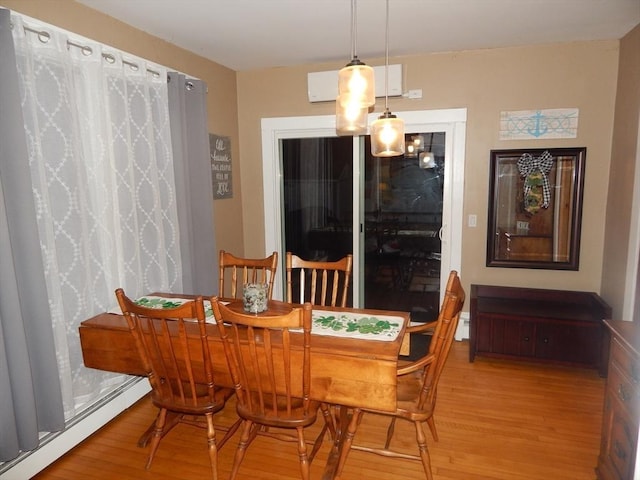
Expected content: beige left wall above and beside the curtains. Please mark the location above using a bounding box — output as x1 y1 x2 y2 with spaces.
0 0 244 253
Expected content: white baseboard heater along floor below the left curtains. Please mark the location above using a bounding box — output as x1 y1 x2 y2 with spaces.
0 377 151 480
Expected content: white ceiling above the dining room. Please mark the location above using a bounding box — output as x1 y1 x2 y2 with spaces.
77 0 640 71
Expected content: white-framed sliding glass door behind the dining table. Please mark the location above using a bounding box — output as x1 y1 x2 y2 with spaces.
262 109 466 320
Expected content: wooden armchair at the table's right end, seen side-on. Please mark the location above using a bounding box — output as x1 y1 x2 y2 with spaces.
336 270 465 480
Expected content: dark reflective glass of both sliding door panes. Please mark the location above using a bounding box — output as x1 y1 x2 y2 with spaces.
280 132 445 321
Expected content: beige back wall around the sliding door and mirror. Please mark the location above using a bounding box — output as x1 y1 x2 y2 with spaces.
238 41 619 302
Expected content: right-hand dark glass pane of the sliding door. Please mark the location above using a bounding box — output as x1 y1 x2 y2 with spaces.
363 132 445 322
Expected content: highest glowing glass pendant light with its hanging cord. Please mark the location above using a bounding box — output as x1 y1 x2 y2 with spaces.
338 0 376 107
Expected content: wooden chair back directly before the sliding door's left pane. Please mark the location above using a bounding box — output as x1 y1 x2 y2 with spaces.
286 252 353 307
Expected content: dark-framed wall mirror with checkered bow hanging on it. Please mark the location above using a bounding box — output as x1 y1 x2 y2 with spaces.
487 147 587 270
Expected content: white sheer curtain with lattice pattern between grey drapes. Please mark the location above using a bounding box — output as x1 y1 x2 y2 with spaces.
11 15 182 419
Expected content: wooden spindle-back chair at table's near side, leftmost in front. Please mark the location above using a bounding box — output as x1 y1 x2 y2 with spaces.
116 288 240 480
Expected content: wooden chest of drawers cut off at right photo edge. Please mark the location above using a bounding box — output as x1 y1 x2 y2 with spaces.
596 320 640 480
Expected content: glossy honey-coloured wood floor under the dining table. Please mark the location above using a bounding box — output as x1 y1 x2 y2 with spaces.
34 341 605 480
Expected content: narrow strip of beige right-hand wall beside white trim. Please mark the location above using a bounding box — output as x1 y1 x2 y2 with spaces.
602 25 640 320
